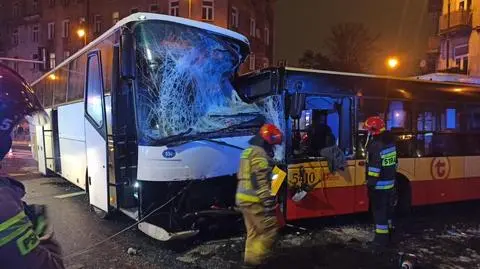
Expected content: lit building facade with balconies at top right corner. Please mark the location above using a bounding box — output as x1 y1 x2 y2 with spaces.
428 0 480 76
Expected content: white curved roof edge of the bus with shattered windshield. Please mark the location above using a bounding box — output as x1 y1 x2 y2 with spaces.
31 12 250 85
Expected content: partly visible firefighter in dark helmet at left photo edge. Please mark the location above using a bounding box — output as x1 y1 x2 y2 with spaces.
0 64 64 269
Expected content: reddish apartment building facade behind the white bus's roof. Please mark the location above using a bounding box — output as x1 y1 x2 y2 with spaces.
0 0 274 81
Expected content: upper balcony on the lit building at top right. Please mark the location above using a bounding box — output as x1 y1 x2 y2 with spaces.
440 10 472 34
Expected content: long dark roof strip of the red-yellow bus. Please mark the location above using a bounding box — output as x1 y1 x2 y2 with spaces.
285 67 480 103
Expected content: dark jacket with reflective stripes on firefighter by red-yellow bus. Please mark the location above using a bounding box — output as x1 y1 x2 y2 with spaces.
367 136 397 190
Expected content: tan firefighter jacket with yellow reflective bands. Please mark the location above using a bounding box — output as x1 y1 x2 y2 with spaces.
236 145 274 207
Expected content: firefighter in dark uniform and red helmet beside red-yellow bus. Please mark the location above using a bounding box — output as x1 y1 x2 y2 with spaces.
365 117 397 246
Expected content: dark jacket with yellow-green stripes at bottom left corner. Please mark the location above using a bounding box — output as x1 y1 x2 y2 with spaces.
0 177 64 269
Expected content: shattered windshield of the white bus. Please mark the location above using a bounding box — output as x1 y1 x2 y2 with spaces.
135 21 261 145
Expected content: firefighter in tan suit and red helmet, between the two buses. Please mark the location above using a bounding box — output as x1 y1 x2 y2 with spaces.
236 124 283 268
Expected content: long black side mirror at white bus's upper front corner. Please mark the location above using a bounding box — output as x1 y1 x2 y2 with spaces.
120 28 137 79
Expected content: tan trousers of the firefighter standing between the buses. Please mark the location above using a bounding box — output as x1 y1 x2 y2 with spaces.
240 203 279 265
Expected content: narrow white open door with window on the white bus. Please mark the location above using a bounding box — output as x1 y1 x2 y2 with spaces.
85 51 109 214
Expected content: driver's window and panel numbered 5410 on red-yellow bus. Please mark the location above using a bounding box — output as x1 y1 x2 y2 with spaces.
287 96 356 220
